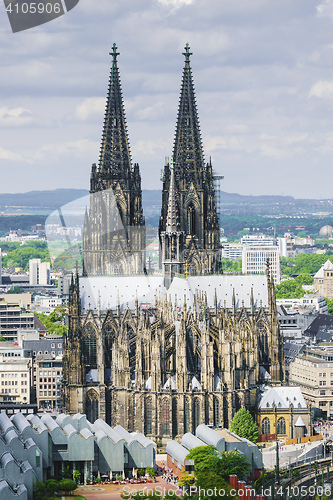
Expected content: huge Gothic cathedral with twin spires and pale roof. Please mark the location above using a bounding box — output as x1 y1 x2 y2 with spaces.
63 45 284 443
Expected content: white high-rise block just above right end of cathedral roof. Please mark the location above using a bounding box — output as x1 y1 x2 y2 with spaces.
242 244 281 284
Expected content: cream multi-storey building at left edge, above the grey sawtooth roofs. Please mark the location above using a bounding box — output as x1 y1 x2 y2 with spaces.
0 358 31 403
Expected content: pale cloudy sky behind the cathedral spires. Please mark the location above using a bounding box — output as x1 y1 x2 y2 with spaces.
0 0 333 198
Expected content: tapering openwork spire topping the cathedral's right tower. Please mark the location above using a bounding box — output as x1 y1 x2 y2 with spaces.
173 43 205 181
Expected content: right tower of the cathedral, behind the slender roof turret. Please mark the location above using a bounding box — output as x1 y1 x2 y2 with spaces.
159 44 220 275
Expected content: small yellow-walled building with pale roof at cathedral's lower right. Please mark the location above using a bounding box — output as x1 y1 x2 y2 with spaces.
257 386 312 441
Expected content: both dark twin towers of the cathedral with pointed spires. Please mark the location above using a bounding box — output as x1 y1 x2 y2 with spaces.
83 44 219 275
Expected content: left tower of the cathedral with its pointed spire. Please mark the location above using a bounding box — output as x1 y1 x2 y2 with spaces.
83 44 146 276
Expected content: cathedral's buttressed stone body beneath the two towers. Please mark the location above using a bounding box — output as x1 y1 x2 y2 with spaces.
63 276 283 441
